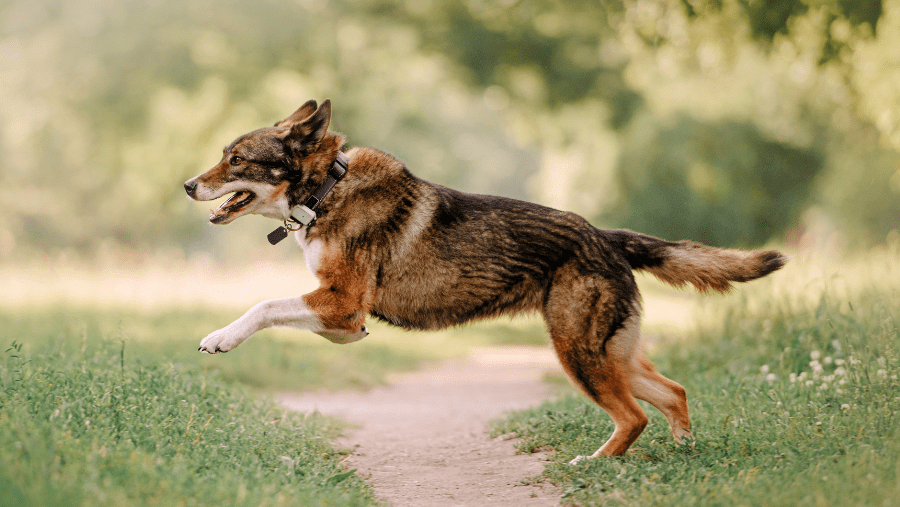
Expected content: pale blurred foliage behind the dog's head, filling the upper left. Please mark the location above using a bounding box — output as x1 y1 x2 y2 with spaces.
0 0 535 254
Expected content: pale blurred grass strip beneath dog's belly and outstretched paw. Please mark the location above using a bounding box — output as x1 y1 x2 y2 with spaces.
0 306 547 390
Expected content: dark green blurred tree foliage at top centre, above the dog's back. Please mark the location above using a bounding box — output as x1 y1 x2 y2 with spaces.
370 0 641 127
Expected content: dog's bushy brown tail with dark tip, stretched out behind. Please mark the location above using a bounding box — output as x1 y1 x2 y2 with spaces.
606 229 787 292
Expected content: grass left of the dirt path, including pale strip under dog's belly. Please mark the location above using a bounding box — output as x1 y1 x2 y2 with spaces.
0 278 546 506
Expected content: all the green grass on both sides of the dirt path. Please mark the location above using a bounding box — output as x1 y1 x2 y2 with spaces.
8 248 900 506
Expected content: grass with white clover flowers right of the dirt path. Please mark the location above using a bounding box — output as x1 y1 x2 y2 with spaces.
494 245 900 506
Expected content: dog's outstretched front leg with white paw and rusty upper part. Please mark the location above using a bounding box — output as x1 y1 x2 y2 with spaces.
198 286 369 354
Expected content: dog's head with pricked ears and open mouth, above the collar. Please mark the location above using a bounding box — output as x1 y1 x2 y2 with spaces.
184 99 343 224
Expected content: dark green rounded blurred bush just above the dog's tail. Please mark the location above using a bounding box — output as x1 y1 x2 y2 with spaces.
604 113 822 246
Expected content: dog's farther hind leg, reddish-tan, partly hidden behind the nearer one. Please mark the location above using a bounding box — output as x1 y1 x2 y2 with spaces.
631 352 691 443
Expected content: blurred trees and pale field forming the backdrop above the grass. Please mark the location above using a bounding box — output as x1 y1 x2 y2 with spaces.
0 0 900 305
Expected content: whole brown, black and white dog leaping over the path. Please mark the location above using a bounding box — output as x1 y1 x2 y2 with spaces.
184 100 786 462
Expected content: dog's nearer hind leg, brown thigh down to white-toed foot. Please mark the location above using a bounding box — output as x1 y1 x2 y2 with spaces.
544 277 647 463
